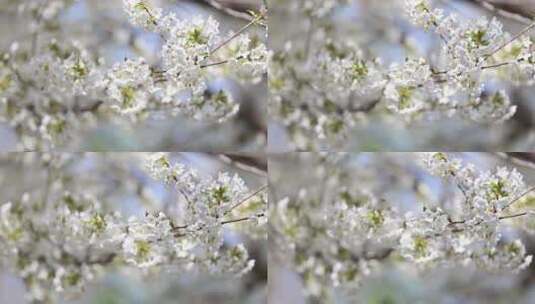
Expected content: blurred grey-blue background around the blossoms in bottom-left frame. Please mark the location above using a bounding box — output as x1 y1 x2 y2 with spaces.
0 153 267 304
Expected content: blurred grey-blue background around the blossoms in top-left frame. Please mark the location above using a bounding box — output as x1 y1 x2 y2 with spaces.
0 0 267 152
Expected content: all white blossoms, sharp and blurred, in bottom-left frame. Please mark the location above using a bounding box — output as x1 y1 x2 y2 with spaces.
0 154 267 301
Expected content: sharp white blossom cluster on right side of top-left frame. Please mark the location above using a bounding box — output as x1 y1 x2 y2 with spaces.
120 1 267 121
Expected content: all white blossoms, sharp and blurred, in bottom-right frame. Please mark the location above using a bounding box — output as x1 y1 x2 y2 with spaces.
270 153 532 299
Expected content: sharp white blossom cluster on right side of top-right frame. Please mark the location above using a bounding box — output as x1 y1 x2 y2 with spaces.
405 0 520 121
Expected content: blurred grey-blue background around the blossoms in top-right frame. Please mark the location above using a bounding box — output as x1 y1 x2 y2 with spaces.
269 0 535 152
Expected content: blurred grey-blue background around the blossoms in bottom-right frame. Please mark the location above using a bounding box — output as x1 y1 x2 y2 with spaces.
268 153 535 304
